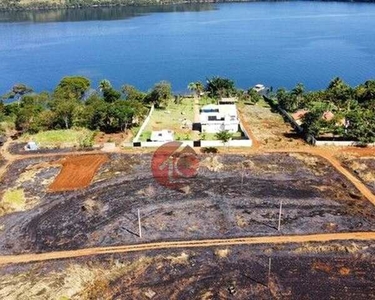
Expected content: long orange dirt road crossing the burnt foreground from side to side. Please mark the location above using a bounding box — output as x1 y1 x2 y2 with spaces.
0 232 375 265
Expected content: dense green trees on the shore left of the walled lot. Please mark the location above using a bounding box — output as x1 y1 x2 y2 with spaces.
0 76 175 137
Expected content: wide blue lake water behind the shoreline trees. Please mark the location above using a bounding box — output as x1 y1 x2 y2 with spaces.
0 2 375 94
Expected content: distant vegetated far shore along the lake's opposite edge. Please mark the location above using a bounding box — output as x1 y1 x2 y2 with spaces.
0 0 375 12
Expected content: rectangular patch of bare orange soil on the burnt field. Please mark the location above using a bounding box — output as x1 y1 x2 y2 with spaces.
49 154 108 192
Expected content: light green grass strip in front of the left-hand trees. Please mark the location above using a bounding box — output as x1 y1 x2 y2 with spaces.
21 129 95 148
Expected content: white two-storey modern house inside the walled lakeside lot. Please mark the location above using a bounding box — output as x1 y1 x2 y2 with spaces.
199 104 239 133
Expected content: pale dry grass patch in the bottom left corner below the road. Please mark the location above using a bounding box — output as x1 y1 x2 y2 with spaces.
0 257 153 300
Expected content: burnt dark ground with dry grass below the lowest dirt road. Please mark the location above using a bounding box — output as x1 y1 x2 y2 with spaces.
0 241 375 300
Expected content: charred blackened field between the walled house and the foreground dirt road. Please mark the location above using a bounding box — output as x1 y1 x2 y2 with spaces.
0 154 375 254
